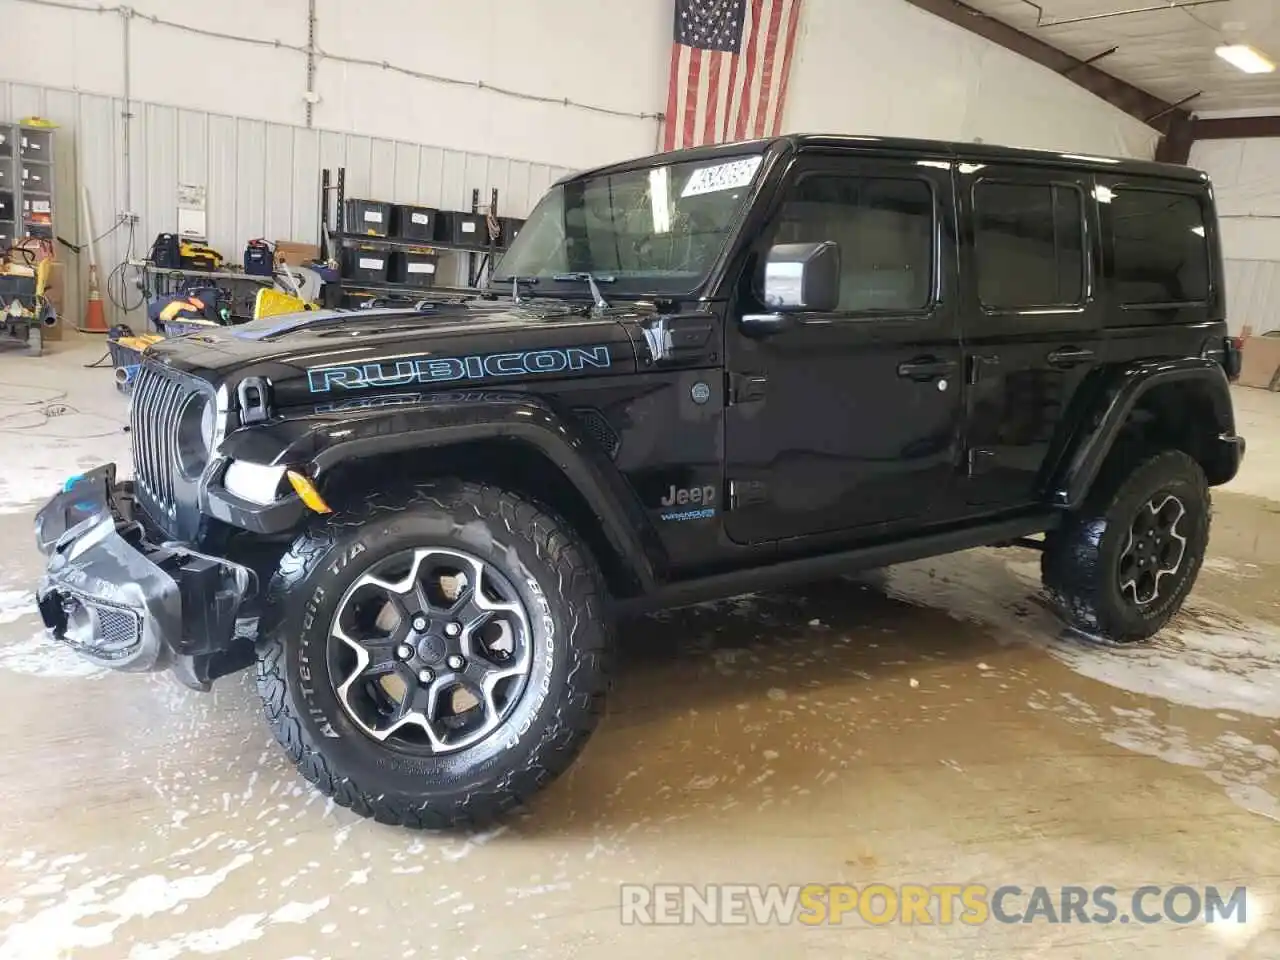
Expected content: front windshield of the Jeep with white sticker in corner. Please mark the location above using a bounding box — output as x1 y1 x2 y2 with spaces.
493 155 762 296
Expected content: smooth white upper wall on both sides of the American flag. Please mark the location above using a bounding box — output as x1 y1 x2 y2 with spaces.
0 0 1156 168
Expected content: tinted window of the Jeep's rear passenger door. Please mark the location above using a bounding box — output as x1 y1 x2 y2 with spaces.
974 180 1084 310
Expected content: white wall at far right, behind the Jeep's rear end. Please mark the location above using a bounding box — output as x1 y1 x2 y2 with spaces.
1190 140 1280 333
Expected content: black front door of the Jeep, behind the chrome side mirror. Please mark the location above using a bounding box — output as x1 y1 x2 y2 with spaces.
726 156 963 543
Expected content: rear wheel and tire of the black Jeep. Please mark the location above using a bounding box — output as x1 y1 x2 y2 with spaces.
1041 451 1210 643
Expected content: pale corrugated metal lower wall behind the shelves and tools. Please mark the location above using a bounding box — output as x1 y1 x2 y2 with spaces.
0 82 567 323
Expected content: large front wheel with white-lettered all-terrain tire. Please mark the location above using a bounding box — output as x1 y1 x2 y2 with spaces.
257 481 612 829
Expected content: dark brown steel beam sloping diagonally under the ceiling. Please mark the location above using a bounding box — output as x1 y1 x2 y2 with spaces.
906 0 1189 133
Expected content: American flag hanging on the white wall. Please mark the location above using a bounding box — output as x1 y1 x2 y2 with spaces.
663 0 801 150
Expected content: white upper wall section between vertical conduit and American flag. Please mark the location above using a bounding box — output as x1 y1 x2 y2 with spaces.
317 0 671 166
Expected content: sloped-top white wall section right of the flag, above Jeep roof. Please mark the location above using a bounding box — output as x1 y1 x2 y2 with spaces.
785 0 1157 157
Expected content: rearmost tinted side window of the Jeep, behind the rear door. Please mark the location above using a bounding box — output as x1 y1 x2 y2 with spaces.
1110 189 1208 305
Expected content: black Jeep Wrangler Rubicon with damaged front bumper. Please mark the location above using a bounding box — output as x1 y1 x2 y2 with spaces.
36 136 1244 827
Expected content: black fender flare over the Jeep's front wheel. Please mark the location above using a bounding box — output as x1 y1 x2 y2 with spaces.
221 392 666 593
